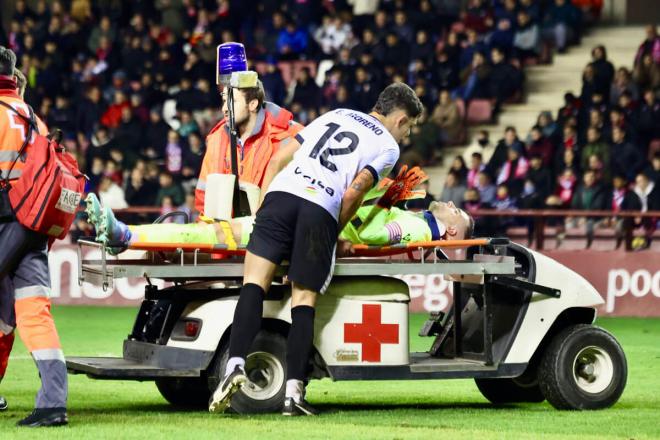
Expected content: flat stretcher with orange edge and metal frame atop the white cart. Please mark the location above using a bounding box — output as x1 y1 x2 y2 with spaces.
78 238 515 289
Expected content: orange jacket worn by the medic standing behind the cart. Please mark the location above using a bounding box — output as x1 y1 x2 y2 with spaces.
195 102 303 213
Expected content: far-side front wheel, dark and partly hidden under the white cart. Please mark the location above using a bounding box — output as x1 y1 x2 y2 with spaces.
474 374 545 405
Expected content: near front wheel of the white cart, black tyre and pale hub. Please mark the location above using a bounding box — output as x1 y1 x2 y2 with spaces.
539 324 628 409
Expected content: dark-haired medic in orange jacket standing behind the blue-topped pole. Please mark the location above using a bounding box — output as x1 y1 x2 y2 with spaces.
195 81 303 217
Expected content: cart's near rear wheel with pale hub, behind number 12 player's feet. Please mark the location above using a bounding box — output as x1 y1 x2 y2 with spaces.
209 330 286 414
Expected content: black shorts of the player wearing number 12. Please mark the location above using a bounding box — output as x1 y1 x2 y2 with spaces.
247 191 339 293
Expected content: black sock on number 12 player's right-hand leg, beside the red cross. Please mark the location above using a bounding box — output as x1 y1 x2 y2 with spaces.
286 306 314 381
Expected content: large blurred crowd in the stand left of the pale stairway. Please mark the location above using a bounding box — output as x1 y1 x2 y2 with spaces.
0 0 599 230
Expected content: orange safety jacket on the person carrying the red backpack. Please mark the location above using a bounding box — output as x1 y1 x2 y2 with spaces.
0 89 48 180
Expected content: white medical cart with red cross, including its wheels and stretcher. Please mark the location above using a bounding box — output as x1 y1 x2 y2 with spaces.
67 238 626 413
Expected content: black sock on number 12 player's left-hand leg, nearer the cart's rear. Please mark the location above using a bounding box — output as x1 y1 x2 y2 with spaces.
229 283 266 359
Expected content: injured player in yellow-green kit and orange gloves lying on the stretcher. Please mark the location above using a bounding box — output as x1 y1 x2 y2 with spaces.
86 167 474 254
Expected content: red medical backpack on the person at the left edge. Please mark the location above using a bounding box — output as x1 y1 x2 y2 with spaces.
0 101 87 239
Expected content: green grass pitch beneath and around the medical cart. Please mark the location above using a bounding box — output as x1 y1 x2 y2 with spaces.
0 307 660 440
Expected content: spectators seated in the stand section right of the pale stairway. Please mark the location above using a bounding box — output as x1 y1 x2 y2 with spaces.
441 26 660 246
